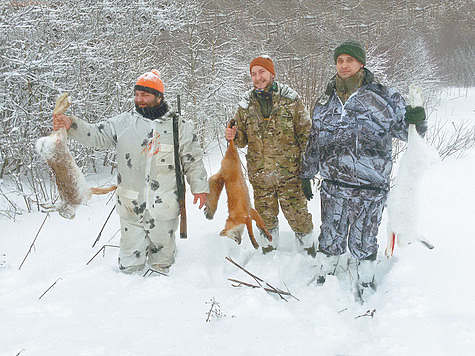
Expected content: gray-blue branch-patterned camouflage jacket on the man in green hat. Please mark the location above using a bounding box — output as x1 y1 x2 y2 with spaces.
300 68 427 190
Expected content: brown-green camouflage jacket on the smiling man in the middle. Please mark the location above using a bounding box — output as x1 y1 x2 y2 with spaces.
234 83 311 184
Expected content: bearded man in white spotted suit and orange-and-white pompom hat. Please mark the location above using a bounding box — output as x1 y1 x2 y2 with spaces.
54 70 209 273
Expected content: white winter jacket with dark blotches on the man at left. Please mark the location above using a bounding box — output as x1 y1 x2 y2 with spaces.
68 107 209 220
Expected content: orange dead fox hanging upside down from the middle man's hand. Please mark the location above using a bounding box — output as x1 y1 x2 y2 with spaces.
205 135 272 249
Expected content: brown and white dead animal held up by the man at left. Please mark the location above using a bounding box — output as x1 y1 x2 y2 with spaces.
36 93 117 219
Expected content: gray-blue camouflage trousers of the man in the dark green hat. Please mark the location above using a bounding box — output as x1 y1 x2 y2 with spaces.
319 181 387 259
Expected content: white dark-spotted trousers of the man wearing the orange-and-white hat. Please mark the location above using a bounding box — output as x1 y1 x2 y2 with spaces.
119 210 178 272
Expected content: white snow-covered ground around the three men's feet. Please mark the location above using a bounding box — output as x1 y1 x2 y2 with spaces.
0 88 475 356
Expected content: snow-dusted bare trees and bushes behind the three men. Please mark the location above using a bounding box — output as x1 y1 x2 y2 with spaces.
0 0 475 218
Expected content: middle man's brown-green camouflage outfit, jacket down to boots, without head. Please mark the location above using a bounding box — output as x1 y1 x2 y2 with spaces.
234 76 313 252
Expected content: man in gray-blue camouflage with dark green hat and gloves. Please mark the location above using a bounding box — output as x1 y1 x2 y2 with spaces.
300 40 427 301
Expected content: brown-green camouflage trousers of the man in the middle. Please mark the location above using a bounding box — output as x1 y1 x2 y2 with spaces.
251 177 313 234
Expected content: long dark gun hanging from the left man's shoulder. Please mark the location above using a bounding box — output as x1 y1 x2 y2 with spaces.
173 95 188 239
